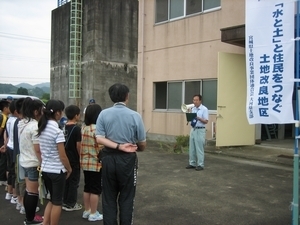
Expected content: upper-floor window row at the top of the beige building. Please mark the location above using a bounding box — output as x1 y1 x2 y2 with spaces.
155 0 221 23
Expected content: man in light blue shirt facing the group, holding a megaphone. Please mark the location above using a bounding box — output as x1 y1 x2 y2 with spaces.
186 95 208 171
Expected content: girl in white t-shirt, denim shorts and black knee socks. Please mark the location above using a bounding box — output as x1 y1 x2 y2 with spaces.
18 97 43 225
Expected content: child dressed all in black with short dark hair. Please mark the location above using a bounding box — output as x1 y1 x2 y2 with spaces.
62 105 82 212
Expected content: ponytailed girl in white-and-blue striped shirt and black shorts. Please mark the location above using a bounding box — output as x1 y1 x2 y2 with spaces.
38 99 72 225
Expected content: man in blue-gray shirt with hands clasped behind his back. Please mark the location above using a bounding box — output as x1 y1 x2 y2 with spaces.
96 83 146 225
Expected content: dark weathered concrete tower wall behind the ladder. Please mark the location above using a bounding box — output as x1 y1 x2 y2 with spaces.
51 0 138 112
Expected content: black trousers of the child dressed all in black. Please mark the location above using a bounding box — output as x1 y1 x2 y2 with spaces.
63 166 80 207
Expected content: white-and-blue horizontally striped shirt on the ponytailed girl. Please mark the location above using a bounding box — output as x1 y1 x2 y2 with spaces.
39 120 67 174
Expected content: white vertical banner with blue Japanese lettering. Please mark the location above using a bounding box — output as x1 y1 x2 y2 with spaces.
245 0 295 124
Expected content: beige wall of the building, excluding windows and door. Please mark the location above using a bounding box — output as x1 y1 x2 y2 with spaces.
138 0 245 139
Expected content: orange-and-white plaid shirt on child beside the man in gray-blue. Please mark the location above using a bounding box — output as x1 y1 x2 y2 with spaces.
80 124 103 172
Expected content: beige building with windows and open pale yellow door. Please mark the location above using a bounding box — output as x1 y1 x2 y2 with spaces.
137 0 255 146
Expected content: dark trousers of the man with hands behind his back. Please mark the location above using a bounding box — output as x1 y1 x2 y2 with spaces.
102 151 137 225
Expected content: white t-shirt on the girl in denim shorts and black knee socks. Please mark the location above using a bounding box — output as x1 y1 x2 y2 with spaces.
18 119 40 168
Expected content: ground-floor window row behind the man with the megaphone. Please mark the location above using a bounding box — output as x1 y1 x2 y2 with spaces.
154 80 217 111
